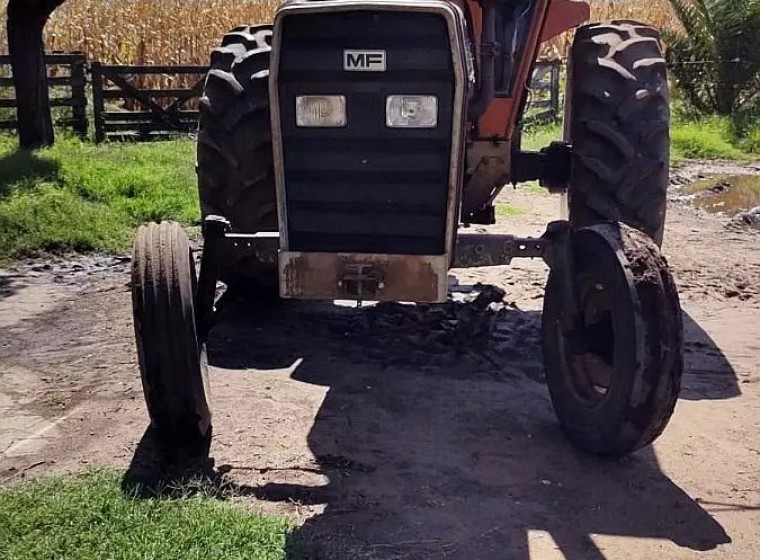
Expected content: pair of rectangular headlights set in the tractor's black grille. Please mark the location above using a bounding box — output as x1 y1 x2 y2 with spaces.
296 95 438 128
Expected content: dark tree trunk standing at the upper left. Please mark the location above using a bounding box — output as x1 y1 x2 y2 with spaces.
7 0 65 149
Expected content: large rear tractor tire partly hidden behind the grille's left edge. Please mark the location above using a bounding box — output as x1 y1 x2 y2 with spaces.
196 25 278 290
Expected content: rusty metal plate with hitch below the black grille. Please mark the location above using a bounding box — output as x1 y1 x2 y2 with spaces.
279 251 449 303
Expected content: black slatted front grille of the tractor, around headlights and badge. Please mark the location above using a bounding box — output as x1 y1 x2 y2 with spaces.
278 11 455 255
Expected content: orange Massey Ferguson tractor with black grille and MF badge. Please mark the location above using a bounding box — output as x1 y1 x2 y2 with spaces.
132 0 683 457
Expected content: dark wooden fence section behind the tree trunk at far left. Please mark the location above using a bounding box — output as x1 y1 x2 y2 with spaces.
0 54 87 136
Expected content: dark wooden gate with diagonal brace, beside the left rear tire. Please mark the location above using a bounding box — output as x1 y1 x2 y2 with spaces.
91 62 208 142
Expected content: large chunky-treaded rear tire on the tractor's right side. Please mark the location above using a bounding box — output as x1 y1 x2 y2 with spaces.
566 20 670 245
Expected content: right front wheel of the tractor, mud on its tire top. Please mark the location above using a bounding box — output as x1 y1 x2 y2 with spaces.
542 223 683 457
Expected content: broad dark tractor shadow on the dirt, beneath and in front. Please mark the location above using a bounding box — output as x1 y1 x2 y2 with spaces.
200 288 736 560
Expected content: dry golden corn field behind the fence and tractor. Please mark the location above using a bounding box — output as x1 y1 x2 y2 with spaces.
0 0 673 78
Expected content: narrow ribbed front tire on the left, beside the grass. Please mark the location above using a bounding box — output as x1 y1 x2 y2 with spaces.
132 222 211 448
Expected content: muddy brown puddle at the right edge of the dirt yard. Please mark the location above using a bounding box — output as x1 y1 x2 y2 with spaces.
686 175 760 216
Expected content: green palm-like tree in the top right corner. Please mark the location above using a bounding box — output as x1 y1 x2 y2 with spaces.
664 0 760 116
